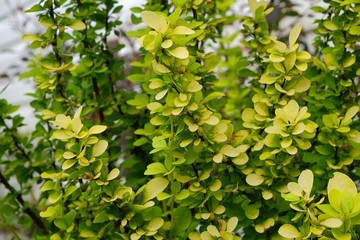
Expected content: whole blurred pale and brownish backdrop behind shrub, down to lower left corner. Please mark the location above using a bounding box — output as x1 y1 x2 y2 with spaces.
0 0 324 240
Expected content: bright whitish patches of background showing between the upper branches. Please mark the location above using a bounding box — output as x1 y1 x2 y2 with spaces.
0 0 321 132
